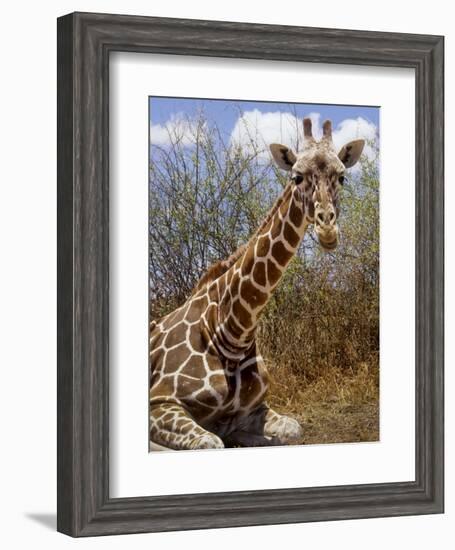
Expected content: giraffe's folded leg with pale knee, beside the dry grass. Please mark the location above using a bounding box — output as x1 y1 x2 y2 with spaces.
228 404 303 447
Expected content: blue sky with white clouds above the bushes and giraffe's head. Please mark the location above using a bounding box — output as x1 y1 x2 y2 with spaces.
149 97 380 172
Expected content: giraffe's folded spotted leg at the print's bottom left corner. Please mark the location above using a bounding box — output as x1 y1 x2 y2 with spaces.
150 403 224 450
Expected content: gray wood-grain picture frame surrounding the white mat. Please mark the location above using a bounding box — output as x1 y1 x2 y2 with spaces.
57 13 444 536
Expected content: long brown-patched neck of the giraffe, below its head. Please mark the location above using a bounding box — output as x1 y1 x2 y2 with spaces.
216 183 309 350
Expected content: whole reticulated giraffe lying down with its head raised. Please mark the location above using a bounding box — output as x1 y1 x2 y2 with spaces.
149 118 364 450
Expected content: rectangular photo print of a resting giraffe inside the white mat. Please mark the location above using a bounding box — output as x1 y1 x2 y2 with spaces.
149 97 380 451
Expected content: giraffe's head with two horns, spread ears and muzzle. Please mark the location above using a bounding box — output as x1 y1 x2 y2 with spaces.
270 118 365 250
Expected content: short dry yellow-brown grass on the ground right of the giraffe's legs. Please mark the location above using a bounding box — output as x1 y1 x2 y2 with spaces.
267 361 379 444
